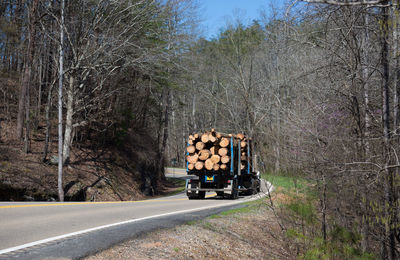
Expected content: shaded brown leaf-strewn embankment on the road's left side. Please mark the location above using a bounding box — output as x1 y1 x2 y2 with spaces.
0 120 174 201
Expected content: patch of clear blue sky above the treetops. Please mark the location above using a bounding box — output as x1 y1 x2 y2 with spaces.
198 0 285 38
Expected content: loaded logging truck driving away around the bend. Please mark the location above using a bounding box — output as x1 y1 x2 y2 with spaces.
186 129 261 199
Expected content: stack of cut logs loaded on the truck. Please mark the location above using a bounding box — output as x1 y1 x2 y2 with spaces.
186 129 248 171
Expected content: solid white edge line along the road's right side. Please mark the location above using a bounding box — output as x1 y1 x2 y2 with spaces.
0 182 272 255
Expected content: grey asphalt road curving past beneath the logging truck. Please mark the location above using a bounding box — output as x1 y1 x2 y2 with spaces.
0 169 270 259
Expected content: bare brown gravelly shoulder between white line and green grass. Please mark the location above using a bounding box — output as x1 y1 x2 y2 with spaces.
86 200 295 260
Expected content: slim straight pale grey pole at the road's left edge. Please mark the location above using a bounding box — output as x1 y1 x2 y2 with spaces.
58 0 65 202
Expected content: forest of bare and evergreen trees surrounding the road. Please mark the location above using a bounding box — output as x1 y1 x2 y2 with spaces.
0 0 400 259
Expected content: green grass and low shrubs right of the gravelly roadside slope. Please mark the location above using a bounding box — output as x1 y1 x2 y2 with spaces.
263 174 376 259
